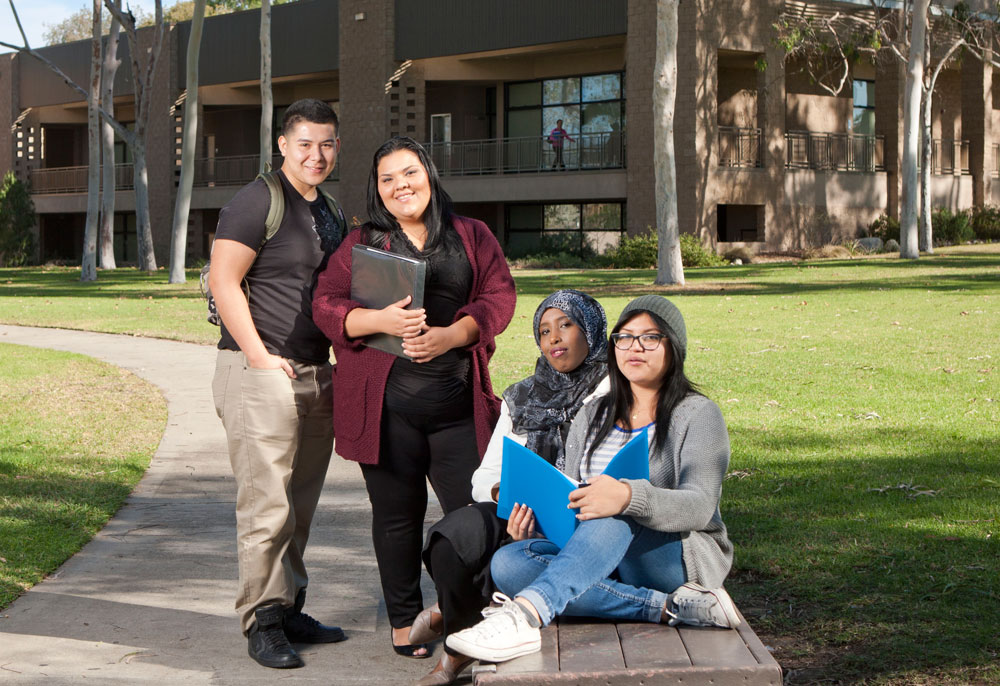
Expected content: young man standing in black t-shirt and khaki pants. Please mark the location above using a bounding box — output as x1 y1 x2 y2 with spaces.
209 100 345 668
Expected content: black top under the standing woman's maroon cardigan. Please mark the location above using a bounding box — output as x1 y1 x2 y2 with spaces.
385 227 472 415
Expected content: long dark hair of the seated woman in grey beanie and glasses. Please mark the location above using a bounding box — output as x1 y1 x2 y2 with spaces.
587 310 701 464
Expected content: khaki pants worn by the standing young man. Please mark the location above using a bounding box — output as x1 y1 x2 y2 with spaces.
212 350 333 634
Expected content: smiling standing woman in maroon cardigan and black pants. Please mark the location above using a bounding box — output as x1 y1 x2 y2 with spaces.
313 137 516 657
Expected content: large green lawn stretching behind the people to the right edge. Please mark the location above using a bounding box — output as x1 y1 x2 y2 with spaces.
0 245 1000 685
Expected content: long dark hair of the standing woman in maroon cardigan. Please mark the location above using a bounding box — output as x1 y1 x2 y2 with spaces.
365 136 451 253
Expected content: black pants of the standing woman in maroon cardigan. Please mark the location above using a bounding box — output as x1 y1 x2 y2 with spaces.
361 405 479 629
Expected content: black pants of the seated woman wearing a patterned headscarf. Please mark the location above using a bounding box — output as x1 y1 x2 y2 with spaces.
423 503 508 654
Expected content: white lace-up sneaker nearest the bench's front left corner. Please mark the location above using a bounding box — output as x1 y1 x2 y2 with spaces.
445 593 542 662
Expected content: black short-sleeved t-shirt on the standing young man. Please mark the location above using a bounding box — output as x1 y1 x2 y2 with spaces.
215 171 342 364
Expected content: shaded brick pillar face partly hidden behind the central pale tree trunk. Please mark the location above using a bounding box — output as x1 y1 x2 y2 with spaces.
625 0 656 234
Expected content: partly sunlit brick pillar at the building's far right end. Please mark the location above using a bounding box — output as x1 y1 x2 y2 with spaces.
962 54 995 207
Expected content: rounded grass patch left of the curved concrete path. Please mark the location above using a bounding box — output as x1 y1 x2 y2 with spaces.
0 344 167 608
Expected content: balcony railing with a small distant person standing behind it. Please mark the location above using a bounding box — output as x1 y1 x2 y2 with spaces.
424 131 625 176
